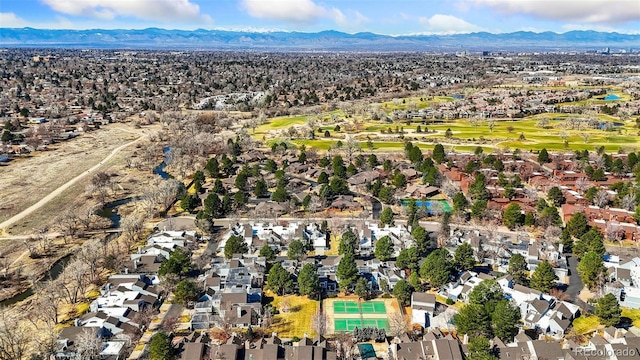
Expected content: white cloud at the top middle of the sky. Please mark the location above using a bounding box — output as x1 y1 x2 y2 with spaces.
242 0 347 24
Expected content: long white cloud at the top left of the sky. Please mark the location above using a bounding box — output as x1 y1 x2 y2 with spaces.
42 0 212 24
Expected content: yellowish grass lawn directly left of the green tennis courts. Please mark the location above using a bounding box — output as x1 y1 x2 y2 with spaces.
265 291 318 338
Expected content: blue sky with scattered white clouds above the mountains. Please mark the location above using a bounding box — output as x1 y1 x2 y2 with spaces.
0 0 640 35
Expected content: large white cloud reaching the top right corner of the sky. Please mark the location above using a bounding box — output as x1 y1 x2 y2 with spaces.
470 0 640 24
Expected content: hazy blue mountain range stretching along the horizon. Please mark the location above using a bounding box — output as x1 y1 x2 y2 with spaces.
0 28 640 52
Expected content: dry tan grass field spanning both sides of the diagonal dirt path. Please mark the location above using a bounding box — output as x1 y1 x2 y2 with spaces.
0 124 160 235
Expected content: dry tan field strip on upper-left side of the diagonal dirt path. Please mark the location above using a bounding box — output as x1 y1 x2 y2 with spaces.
0 125 140 231
